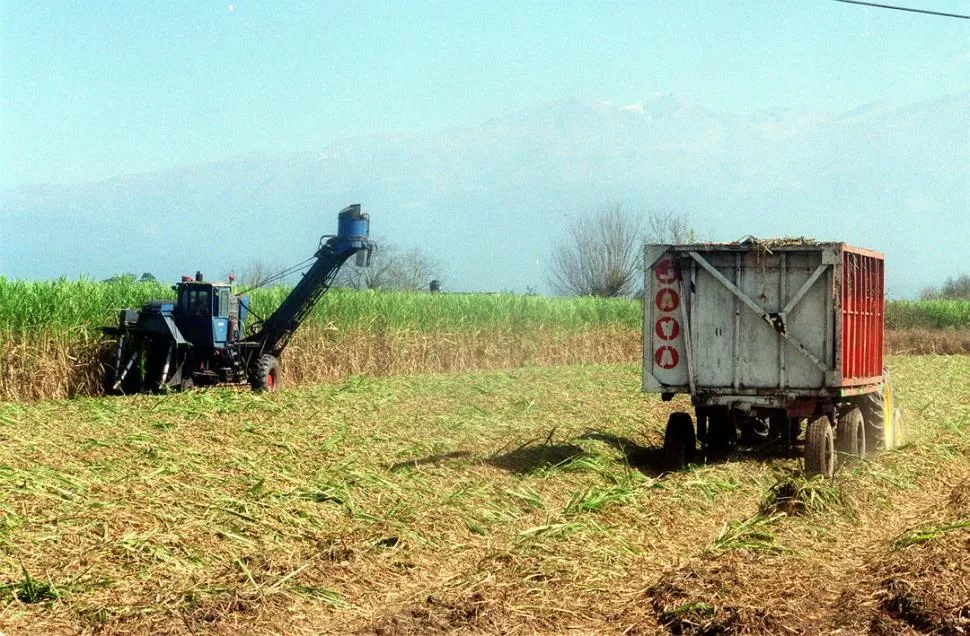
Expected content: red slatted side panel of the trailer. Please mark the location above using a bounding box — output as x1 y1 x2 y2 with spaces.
841 246 885 385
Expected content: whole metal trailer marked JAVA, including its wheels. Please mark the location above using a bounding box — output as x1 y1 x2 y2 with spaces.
643 239 898 476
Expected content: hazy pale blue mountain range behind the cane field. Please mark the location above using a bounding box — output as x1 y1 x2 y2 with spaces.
0 93 970 297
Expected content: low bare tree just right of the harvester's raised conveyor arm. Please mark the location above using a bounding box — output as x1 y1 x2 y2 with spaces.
336 240 441 291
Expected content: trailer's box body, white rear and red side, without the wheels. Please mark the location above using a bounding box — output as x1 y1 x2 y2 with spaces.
643 242 883 398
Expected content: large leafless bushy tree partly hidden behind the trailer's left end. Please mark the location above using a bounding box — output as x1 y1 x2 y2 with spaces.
548 205 694 296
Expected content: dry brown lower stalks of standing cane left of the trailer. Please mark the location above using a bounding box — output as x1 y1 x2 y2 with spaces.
0 325 642 402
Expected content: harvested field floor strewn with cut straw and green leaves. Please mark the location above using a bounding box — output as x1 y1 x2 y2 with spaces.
0 356 970 634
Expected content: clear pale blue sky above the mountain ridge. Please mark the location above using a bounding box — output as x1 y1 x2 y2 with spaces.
0 0 970 188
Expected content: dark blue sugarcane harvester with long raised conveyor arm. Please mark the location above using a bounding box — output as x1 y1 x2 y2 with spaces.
102 204 374 394
